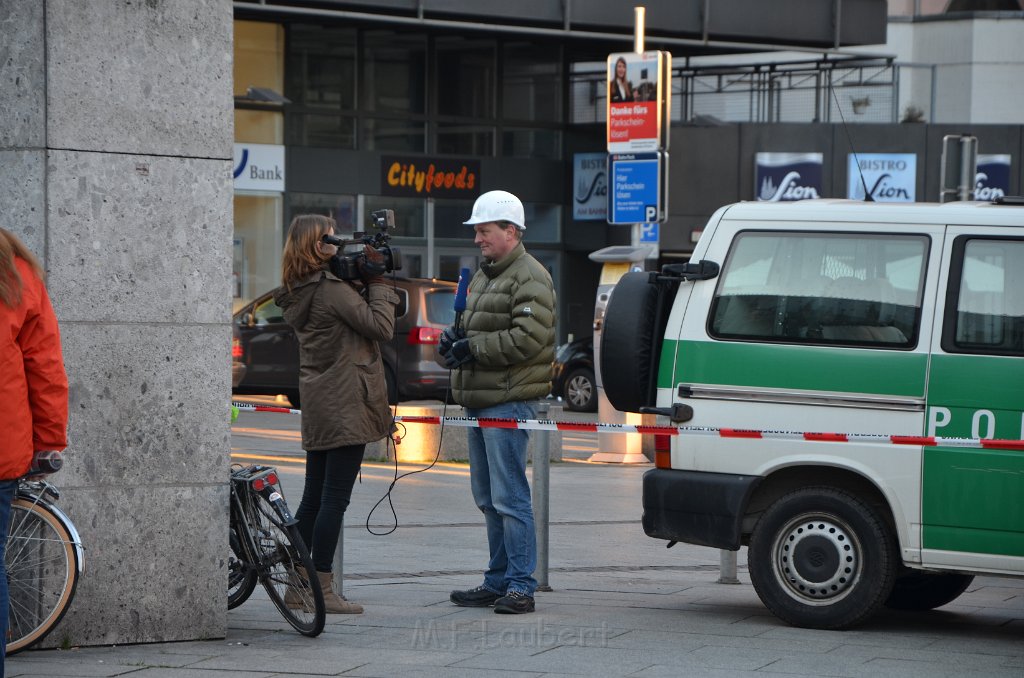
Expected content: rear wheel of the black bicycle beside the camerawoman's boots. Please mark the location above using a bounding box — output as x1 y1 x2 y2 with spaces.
242 492 327 637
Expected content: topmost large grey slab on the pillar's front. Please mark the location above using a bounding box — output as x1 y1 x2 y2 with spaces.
46 0 233 159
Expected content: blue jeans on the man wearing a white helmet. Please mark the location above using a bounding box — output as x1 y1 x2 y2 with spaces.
465 402 537 596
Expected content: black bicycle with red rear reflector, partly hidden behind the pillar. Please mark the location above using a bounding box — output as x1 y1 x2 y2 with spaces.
227 464 327 637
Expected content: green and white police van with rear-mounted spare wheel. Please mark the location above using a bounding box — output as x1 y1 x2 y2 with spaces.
600 199 1024 629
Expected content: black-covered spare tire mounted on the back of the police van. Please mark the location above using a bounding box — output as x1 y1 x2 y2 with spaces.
599 272 667 412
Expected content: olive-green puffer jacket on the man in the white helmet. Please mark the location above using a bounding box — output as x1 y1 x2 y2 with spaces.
452 243 555 408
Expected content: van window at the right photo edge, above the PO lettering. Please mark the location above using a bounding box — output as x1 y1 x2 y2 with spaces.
942 236 1024 355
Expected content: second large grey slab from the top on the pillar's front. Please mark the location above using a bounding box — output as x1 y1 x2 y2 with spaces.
47 151 232 323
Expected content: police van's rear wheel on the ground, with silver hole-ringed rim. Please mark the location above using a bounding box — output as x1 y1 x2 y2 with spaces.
748 488 899 629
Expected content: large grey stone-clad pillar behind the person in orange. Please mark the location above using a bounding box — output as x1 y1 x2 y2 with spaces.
0 0 233 646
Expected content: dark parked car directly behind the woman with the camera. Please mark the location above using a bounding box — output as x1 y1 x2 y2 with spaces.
232 278 456 408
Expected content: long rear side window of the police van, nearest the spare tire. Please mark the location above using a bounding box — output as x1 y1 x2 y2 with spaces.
708 231 929 349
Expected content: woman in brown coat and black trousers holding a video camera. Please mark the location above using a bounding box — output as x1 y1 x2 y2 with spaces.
273 214 398 615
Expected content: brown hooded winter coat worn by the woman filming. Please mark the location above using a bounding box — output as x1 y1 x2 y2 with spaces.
273 270 398 451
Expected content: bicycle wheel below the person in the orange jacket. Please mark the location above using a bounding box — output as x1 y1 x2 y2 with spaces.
5 497 80 655
